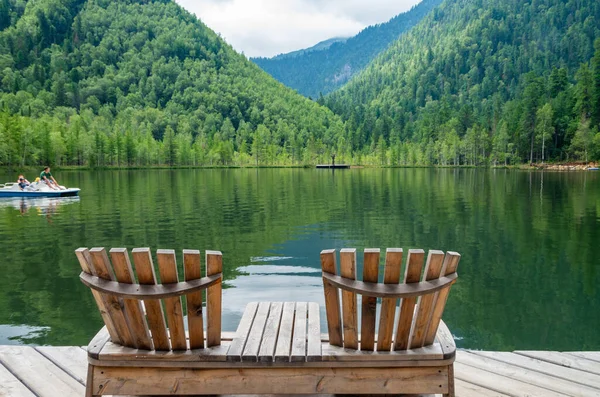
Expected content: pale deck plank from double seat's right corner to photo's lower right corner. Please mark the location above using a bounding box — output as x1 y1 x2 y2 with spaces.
456 351 600 397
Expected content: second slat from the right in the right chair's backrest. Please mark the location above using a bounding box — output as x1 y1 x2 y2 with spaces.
410 250 444 349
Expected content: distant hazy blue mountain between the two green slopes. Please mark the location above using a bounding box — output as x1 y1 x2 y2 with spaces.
252 0 442 98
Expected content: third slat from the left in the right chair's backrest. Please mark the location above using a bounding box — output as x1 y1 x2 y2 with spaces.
360 248 380 351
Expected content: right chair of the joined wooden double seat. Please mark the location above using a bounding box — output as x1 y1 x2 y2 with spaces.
321 249 460 396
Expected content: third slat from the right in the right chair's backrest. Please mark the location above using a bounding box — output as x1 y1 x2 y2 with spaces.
394 249 425 350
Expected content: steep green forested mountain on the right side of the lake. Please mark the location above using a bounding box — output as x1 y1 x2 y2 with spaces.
323 0 600 165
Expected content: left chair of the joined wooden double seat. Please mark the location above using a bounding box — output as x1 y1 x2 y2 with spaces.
75 248 226 396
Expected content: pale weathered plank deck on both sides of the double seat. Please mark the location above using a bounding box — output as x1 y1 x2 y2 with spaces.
0 346 600 397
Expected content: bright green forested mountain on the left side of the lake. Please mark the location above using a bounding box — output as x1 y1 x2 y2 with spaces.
0 0 345 166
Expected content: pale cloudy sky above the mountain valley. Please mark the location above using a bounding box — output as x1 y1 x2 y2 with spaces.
176 0 420 57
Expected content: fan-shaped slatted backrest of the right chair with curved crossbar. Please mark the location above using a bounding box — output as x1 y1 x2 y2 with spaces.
321 248 460 353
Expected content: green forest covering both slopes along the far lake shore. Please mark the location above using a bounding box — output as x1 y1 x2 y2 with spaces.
0 0 600 167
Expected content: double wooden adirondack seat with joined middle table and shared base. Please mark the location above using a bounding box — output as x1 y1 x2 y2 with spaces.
76 248 459 397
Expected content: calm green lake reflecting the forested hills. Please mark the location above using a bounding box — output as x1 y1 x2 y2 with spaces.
0 169 600 350
